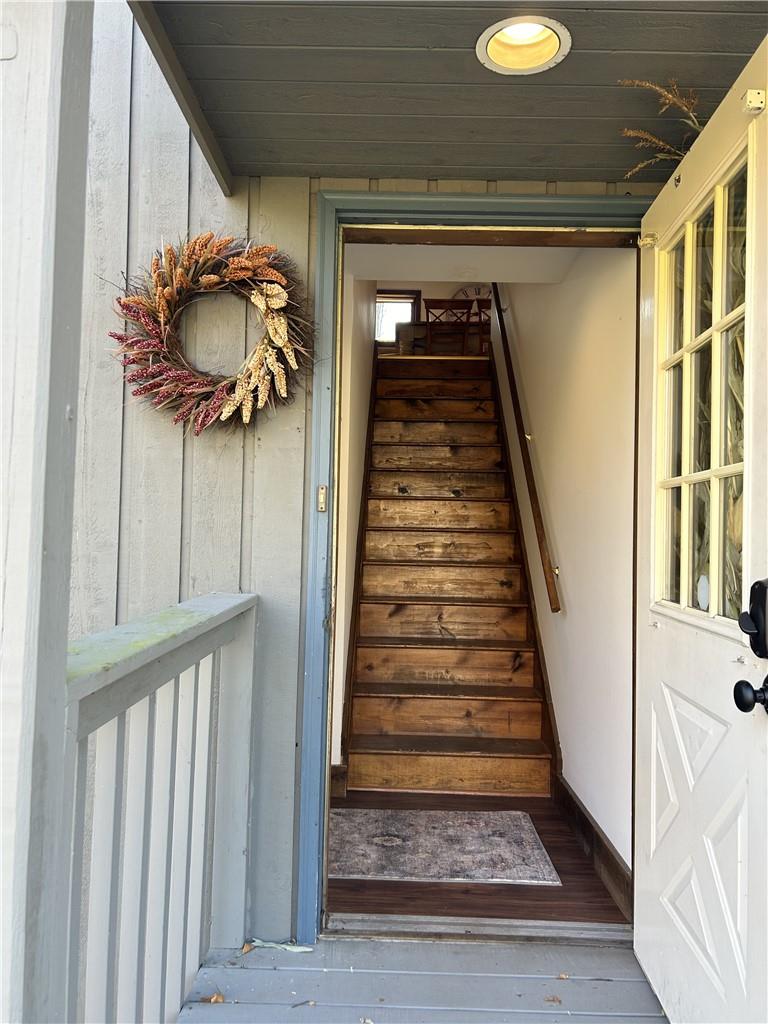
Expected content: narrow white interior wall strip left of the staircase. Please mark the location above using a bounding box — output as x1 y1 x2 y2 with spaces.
331 273 376 764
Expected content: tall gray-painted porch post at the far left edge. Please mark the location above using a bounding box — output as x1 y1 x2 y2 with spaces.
0 2 93 1022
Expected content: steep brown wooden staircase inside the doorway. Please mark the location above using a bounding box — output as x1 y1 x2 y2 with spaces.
345 355 551 796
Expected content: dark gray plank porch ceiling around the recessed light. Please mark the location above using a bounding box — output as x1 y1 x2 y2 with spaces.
137 0 768 181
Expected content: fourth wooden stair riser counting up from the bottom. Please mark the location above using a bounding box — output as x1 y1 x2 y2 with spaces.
360 601 528 640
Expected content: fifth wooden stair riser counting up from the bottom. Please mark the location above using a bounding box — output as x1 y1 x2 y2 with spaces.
362 565 522 601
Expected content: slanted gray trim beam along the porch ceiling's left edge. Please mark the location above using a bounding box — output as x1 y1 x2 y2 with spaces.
128 0 232 196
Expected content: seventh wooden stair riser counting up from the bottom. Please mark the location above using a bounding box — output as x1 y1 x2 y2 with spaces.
368 498 512 529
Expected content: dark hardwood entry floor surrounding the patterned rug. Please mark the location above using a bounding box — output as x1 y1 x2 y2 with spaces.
327 792 627 924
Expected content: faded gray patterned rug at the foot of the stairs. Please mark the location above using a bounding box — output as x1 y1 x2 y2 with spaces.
328 807 562 886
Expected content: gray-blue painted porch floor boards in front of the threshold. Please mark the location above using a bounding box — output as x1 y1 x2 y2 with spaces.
178 938 666 1024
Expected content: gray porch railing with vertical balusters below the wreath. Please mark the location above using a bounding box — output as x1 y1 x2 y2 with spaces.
63 594 257 1022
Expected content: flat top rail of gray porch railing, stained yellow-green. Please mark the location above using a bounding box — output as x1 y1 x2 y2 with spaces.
67 594 258 701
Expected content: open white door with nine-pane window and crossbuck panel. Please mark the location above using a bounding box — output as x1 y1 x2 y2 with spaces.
635 41 768 1022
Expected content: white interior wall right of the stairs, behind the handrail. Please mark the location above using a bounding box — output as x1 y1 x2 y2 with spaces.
495 249 636 864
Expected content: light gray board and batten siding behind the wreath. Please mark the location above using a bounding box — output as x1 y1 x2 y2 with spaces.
70 3 655 938
